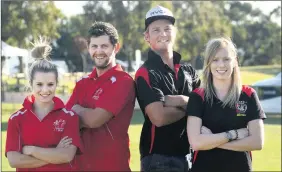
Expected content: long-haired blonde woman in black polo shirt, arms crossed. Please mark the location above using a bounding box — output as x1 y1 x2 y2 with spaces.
186 38 266 172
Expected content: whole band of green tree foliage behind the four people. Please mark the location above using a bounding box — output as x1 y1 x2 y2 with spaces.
1 1 281 72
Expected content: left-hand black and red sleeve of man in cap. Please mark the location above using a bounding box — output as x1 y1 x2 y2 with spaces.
135 67 164 109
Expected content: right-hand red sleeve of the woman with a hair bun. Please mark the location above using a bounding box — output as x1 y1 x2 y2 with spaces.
62 111 83 154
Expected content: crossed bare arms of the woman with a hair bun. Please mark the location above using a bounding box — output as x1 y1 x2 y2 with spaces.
7 137 77 168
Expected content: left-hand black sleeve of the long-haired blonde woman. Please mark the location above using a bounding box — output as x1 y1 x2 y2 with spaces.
186 89 204 119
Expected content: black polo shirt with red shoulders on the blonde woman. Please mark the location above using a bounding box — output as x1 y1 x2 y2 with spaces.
186 86 266 172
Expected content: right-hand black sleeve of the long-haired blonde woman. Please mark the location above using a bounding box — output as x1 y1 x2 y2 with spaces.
247 90 266 121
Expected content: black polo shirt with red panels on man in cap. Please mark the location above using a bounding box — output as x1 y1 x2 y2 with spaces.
135 50 200 158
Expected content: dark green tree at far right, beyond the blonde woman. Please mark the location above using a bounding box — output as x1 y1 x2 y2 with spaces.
224 2 281 65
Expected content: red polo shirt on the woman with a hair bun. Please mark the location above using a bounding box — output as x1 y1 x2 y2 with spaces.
5 96 82 171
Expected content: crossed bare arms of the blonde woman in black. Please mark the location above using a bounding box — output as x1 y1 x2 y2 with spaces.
187 116 264 151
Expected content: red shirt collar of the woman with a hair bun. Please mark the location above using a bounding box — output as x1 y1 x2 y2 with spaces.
23 95 65 111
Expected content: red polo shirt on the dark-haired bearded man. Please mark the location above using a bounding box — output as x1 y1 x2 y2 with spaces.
66 65 135 171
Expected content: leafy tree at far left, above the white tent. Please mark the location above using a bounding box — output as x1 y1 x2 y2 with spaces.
1 1 64 72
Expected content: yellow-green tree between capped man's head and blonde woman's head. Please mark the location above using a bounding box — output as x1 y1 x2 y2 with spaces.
173 1 231 65
